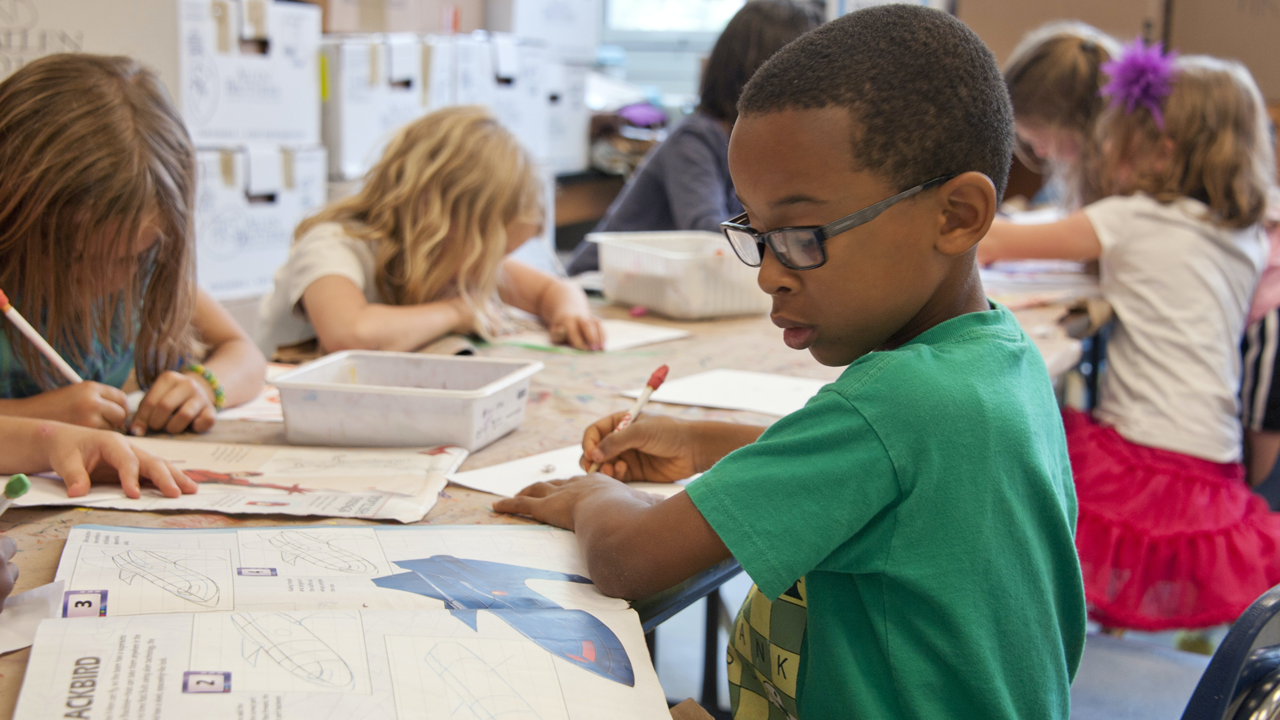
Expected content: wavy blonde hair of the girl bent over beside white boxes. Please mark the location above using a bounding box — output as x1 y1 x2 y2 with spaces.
294 106 543 334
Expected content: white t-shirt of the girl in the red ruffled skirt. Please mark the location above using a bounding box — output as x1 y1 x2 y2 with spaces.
1084 193 1267 462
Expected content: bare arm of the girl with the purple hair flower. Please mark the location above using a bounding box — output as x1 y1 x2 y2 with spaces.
978 210 1102 264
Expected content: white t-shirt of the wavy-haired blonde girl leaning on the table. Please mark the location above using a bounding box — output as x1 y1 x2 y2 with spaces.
255 223 383 357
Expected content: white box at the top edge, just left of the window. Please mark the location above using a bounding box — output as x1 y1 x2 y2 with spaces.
485 0 604 64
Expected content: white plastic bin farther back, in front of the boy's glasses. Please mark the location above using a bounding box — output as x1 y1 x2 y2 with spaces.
586 231 773 320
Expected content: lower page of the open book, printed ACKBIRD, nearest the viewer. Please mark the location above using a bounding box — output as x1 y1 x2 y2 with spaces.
14 610 671 720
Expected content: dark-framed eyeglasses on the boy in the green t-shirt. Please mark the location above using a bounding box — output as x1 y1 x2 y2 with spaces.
721 176 955 270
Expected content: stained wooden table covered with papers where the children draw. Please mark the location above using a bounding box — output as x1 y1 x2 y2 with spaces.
0 298 1080 717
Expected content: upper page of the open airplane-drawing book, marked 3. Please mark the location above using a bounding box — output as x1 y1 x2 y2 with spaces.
55 525 627 618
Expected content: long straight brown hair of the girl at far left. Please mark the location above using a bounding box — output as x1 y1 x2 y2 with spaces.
0 54 196 388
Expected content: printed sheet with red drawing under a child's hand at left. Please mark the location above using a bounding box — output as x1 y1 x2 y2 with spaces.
0 438 467 523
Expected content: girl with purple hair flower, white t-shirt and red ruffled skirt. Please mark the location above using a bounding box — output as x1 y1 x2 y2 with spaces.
978 41 1280 630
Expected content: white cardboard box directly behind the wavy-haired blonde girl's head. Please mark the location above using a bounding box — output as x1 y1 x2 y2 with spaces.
321 33 456 181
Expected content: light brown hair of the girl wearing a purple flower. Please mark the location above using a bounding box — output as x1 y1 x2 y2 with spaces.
1092 55 1275 228
